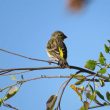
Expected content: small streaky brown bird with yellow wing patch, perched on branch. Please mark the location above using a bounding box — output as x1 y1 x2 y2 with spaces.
47 31 68 68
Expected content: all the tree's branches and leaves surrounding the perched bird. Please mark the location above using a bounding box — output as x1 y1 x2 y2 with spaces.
0 40 110 110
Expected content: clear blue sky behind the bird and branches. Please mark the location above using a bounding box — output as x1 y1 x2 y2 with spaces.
0 0 110 110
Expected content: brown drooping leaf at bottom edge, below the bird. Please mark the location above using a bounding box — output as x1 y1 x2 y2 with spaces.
46 95 57 110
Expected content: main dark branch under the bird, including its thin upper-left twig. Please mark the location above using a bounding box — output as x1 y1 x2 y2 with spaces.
0 49 108 79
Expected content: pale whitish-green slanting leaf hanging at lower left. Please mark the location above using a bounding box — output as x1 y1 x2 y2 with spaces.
3 86 19 101
